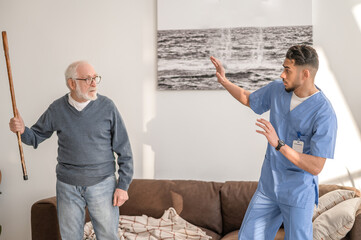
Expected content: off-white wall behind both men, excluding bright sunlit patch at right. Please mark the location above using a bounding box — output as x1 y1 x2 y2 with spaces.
0 0 361 239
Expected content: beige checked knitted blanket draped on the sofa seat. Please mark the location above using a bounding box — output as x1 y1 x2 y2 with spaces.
83 208 211 240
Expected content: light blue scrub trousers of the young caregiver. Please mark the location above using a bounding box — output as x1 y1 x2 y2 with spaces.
238 189 314 240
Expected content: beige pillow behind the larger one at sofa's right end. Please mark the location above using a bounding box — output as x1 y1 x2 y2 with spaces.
312 190 355 221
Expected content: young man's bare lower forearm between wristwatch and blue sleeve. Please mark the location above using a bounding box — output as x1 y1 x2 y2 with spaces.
280 145 326 175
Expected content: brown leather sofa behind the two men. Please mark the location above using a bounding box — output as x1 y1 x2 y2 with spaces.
31 179 361 240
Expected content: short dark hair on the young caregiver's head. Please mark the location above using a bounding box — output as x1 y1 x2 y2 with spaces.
286 45 318 70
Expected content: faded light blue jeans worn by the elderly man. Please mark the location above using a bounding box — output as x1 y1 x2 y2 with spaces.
56 175 119 240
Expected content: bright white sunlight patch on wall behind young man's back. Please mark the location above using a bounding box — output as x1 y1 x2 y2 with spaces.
316 47 361 188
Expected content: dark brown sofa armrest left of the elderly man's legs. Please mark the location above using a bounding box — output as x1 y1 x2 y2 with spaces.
31 197 61 240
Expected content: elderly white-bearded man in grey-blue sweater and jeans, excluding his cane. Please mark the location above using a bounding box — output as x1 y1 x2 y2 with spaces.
9 61 133 240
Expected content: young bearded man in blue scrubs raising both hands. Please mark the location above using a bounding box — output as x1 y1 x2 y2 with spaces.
211 45 337 240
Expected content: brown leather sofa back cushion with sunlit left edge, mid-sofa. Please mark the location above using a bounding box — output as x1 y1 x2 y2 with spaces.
172 180 222 234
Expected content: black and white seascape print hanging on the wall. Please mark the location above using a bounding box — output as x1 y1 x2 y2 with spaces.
158 0 313 91
